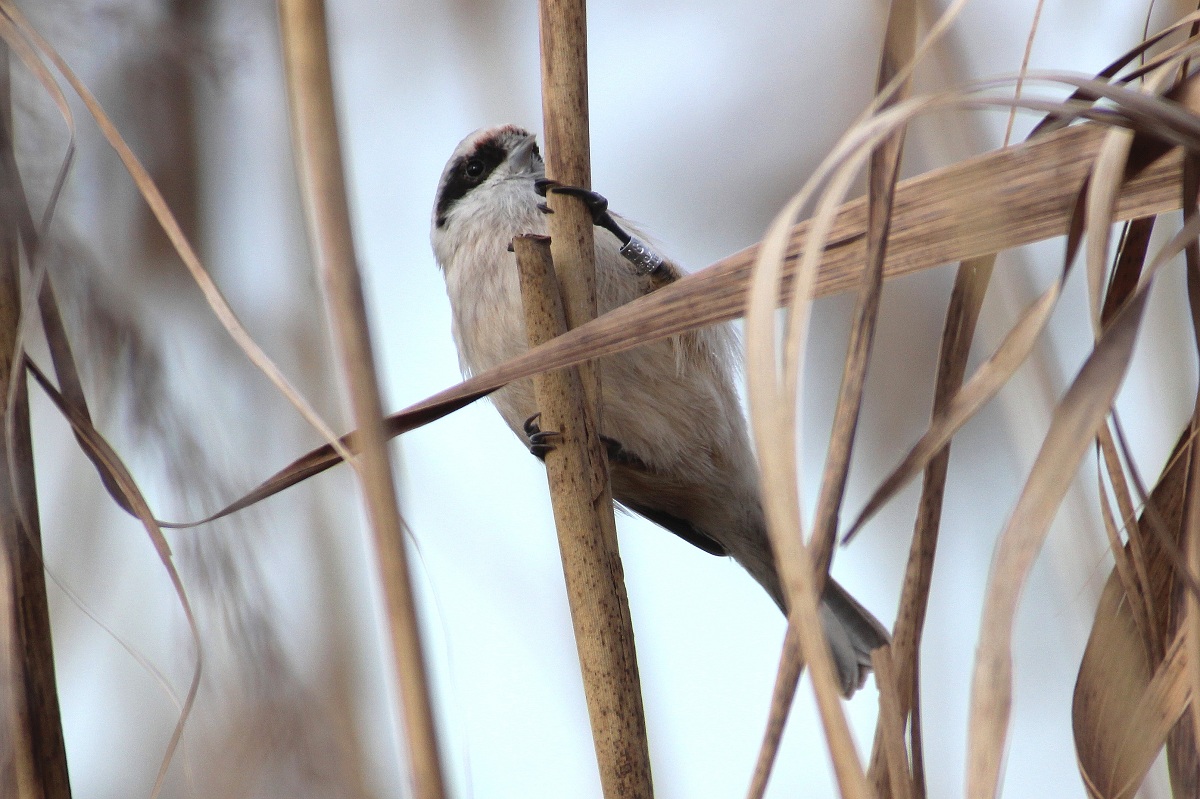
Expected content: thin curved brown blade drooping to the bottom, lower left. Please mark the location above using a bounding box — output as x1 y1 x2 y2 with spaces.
25 359 204 797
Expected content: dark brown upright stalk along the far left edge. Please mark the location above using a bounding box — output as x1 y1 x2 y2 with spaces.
0 38 71 799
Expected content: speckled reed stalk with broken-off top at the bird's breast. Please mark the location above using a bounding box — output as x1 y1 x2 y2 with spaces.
512 236 653 799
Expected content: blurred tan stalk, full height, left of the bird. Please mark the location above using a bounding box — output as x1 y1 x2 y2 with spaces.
278 0 445 799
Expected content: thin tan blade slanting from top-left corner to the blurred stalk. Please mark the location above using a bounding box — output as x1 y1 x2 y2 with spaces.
0 0 353 461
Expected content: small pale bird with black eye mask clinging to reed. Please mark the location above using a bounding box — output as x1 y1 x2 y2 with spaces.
431 125 888 697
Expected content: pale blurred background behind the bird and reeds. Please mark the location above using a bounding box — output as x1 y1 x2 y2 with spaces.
14 0 1196 799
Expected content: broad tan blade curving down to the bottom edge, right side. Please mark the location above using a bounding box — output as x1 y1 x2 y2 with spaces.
967 193 1200 799
